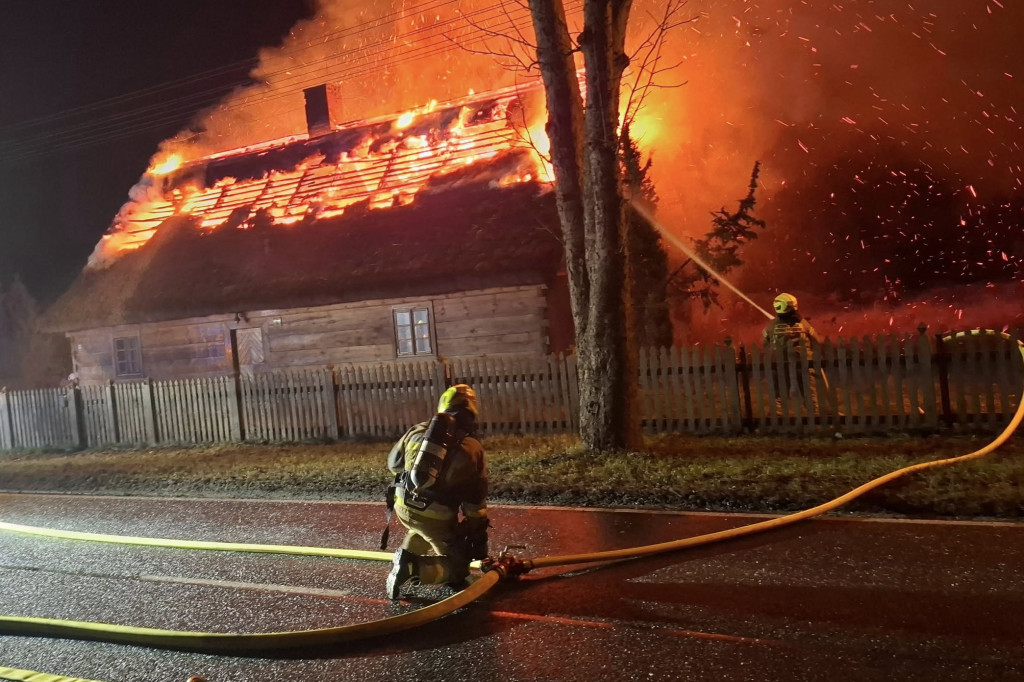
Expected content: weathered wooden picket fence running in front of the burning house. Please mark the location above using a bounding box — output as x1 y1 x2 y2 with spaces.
0 334 1024 451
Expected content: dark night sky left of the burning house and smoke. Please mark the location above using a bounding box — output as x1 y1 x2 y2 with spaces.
0 0 313 301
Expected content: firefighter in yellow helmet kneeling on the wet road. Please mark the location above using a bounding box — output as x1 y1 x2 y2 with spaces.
381 384 488 599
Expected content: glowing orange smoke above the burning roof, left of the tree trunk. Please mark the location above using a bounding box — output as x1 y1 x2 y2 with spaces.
154 0 528 162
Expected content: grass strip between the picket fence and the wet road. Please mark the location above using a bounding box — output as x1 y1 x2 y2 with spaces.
0 435 1024 519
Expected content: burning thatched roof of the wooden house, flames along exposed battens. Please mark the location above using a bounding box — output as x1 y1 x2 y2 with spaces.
44 84 562 331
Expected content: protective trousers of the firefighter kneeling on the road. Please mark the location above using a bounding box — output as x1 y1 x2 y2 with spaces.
394 505 469 585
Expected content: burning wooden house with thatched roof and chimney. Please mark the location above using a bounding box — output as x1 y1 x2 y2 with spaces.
47 86 572 383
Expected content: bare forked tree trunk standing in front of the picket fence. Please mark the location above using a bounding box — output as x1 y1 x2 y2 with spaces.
530 0 640 450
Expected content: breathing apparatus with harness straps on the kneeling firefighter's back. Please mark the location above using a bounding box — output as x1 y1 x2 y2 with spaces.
381 411 470 550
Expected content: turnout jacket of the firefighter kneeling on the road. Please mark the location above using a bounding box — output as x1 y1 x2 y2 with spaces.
388 422 487 518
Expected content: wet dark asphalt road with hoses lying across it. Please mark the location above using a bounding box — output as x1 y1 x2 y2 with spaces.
0 495 1024 682
